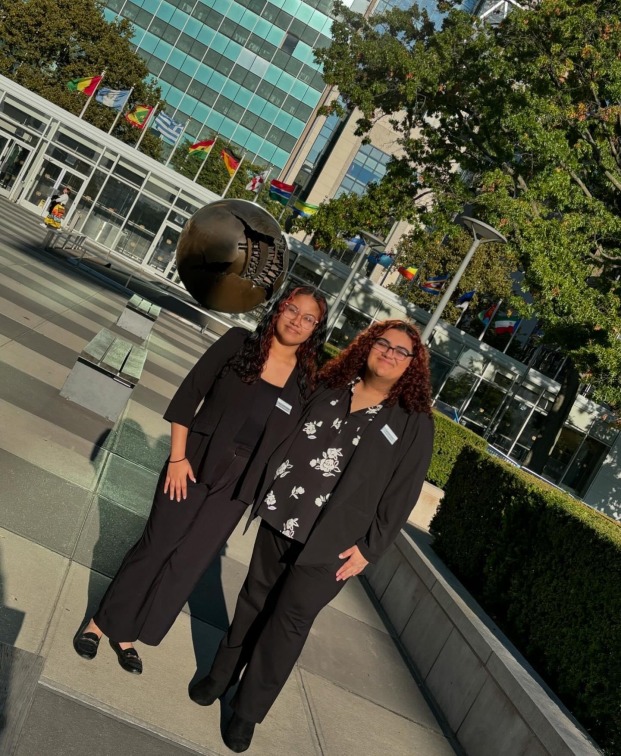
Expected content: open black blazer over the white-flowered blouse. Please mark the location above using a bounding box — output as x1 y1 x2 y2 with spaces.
240 388 433 565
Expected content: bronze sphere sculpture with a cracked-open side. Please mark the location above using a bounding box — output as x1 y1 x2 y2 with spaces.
177 199 289 312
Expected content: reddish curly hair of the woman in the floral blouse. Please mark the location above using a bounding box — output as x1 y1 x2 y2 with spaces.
319 320 431 415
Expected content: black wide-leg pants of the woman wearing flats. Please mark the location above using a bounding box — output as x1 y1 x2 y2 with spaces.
93 457 248 646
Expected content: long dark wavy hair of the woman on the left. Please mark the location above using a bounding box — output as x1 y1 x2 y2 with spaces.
225 286 328 397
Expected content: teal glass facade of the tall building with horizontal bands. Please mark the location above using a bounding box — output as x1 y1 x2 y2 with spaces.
105 0 354 169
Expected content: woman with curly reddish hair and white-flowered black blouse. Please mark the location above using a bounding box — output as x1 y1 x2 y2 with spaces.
190 320 433 753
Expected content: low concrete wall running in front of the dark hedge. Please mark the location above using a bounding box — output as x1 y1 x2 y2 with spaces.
365 526 599 756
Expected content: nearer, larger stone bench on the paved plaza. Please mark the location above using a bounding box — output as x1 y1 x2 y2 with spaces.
60 328 147 422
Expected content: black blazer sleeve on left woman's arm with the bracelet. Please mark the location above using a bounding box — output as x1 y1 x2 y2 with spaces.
164 328 249 428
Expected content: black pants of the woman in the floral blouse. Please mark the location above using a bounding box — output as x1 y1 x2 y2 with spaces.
209 523 345 722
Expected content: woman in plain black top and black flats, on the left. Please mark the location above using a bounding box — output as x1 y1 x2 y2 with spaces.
74 287 327 674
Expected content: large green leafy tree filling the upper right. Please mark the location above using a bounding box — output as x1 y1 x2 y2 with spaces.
316 0 621 467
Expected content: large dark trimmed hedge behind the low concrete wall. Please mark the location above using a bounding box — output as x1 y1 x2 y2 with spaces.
430 448 621 755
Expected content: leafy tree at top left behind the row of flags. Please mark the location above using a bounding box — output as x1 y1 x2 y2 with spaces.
0 0 165 158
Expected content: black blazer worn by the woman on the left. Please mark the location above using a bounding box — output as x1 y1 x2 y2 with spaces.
164 328 303 489
